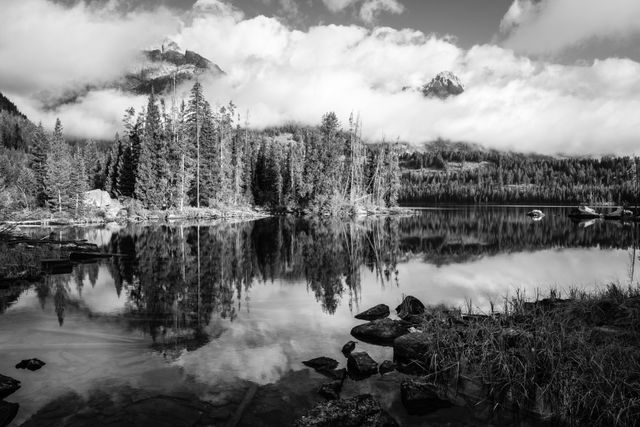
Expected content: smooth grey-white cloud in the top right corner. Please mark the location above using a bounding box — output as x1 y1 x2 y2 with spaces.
500 0 640 54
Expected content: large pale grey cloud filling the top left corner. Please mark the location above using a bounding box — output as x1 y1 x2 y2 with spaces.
0 0 177 92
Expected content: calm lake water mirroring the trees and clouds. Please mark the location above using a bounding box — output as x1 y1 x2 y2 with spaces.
0 207 637 424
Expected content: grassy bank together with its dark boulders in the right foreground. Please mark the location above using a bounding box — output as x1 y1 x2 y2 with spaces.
295 285 640 426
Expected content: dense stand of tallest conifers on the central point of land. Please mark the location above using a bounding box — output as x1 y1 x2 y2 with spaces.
105 83 400 213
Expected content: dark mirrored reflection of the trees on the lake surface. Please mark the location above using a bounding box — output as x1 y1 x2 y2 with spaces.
21 208 636 351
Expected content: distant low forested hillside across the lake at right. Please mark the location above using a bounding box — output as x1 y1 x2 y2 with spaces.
399 149 638 204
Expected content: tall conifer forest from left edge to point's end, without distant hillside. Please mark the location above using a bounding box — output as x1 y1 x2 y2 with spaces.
0 82 400 217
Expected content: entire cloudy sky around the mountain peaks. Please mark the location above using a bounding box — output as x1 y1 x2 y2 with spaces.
0 0 640 155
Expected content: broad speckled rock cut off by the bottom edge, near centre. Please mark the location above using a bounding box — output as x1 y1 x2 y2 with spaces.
293 394 398 427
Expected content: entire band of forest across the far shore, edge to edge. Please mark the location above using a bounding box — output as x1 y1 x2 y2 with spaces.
0 83 638 212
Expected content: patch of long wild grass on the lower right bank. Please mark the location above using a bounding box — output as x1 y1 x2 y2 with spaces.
416 285 640 426
